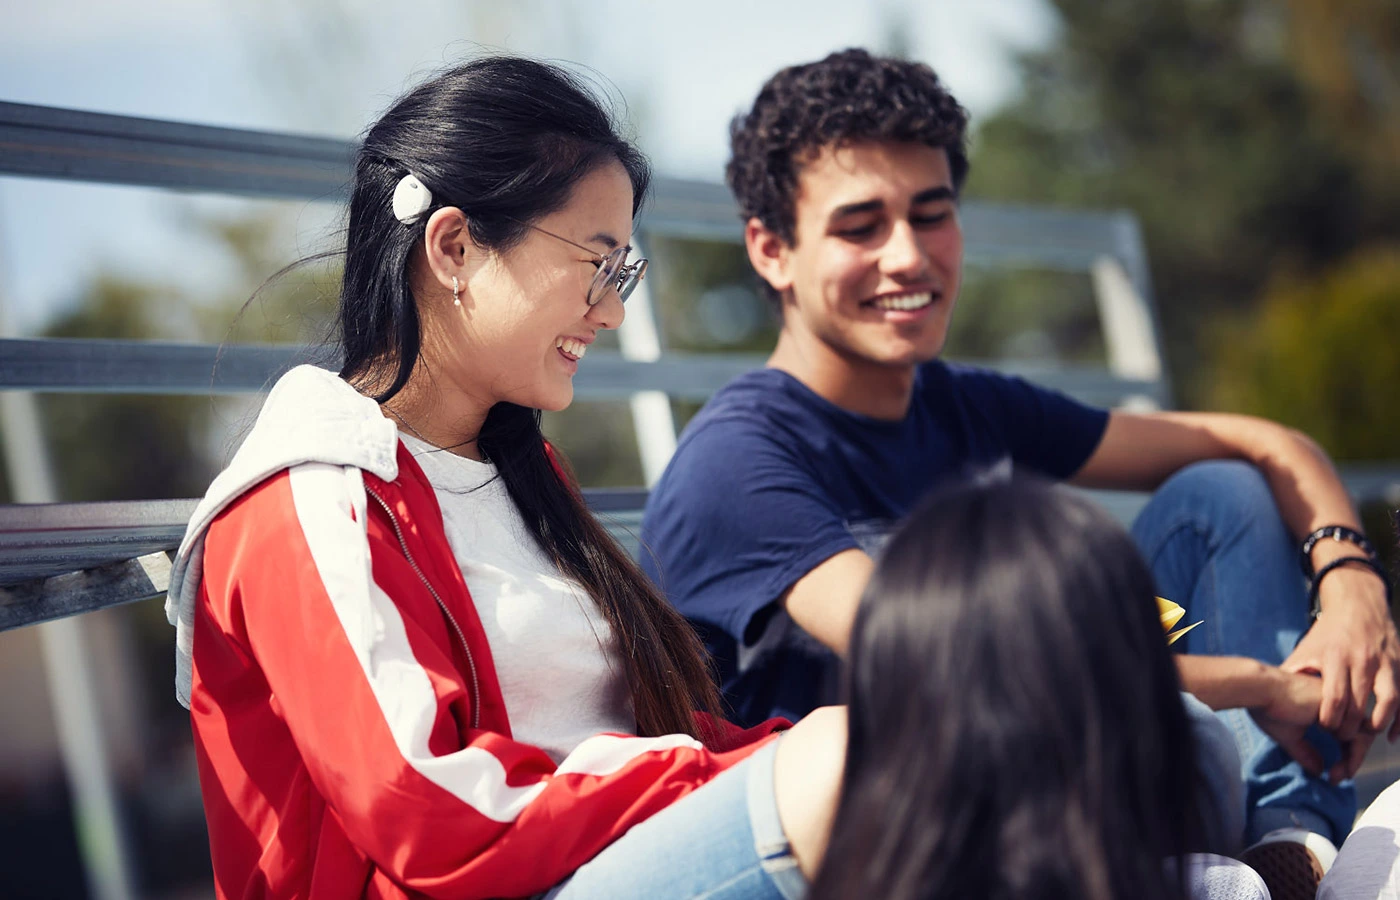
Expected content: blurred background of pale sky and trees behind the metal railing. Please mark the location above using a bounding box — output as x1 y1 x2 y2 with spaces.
0 0 1400 897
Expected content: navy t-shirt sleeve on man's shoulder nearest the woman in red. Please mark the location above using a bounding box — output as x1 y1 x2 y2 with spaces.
641 419 858 644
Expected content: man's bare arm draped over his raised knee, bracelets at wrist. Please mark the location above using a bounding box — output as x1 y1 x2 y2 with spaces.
1072 412 1400 753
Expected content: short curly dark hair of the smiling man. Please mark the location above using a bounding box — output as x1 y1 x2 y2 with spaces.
725 48 967 244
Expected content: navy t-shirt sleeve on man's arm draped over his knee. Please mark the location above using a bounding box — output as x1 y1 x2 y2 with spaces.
952 368 1109 480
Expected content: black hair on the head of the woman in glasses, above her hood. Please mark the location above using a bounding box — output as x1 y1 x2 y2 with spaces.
340 56 651 400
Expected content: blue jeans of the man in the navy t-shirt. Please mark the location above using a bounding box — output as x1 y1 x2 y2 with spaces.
1133 462 1357 844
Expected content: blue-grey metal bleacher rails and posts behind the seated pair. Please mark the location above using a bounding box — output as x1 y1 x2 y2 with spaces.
0 95 1187 630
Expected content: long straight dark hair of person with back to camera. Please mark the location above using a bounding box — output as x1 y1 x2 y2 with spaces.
812 480 1201 900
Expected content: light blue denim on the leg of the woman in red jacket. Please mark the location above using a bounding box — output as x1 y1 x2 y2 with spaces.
545 740 806 900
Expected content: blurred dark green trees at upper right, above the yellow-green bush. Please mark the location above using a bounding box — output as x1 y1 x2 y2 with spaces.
967 0 1400 419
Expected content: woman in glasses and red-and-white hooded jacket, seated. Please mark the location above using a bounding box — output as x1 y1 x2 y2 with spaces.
168 57 844 900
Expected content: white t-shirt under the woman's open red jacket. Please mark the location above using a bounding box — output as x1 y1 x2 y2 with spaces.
399 431 637 763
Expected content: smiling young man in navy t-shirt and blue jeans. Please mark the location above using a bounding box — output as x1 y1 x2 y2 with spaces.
643 50 1400 873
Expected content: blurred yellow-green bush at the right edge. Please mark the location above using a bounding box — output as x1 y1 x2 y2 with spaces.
1211 245 1400 459
